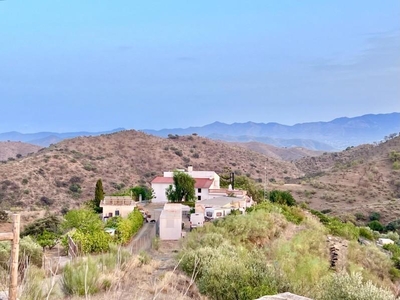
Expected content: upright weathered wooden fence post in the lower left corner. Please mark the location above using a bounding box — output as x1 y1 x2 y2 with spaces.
8 214 20 300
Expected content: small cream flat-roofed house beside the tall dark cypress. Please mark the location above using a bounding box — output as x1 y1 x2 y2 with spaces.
100 196 136 219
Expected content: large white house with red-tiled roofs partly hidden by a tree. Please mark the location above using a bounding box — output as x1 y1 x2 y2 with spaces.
151 166 220 203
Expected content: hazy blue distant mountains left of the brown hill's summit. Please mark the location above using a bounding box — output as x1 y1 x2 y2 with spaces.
0 128 124 147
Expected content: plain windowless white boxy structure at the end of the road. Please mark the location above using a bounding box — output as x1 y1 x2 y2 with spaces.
159 203 182 241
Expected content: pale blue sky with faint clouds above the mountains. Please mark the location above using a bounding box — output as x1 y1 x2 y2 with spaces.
0 0 400 133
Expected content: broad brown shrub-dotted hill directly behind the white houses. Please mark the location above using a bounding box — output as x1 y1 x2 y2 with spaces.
0 130 303 210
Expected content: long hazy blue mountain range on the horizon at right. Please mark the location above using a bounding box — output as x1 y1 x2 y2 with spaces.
143 112 400 151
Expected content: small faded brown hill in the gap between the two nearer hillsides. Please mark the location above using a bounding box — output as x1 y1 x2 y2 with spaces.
232 142 324 161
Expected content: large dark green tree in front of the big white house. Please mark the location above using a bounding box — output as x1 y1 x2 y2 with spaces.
165 171 196 202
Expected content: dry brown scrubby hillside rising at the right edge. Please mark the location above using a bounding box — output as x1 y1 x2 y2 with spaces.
284 137 400 222
